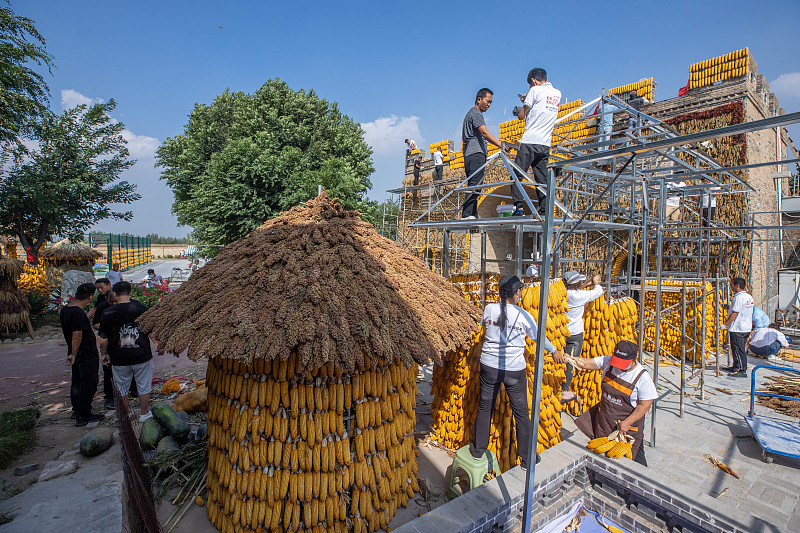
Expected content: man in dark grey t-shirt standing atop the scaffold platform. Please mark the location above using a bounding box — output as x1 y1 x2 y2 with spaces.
461 88 500 220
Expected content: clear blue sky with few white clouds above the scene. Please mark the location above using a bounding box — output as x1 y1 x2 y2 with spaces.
12 0 800 236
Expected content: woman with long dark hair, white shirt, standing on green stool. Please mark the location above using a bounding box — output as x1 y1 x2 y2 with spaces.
470 276 563 468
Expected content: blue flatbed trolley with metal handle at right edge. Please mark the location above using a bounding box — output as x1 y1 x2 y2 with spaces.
744 365 800 463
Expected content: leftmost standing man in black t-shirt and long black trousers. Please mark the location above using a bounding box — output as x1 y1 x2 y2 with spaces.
59 283 103 426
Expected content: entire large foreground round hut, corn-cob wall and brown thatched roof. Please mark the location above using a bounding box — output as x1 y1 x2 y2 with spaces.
140 193 480 531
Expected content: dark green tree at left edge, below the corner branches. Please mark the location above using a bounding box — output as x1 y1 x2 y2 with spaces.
0 100 140 257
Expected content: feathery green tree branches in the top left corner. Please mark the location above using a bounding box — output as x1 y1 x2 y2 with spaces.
0 2 53 147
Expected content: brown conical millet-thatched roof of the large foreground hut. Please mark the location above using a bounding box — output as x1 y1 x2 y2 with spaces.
139 192 480 373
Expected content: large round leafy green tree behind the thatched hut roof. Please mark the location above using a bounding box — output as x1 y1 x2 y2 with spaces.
157 79 374 244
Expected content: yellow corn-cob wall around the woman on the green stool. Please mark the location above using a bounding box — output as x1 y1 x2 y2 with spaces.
431 280 567 471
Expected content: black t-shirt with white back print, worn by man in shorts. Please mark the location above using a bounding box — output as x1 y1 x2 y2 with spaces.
100 300 153 366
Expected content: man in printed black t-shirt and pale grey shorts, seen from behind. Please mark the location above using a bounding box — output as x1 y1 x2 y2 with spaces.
100 281 153 422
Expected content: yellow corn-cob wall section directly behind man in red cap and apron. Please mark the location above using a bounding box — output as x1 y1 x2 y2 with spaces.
566 298 638 416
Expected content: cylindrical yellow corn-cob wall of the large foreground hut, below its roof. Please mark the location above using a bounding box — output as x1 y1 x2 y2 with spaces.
206 353 419 533
